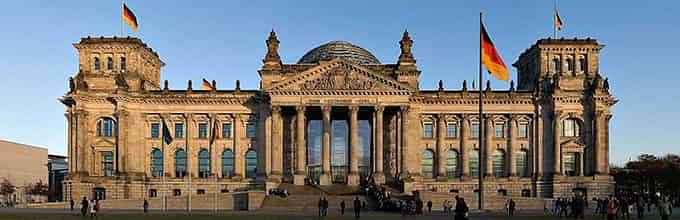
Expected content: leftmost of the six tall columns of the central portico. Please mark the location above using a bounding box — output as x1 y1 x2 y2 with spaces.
271 106 283 180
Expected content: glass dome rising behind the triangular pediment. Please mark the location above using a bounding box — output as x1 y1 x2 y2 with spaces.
298 41 380 64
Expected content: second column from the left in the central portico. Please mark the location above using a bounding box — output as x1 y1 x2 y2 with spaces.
293 106 307 186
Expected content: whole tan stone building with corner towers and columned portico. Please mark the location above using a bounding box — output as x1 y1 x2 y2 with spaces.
61 32 616 203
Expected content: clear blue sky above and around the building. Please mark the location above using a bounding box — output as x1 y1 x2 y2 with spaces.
0 0 680 164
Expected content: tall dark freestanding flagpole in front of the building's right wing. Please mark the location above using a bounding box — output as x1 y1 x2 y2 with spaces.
477 12 484 210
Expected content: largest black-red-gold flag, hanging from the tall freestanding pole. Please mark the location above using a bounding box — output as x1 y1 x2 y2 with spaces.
480 22 510 81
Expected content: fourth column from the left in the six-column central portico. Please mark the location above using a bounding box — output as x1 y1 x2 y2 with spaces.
347 106 360 185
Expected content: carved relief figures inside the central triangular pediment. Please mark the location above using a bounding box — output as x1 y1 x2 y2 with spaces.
302 67 375 90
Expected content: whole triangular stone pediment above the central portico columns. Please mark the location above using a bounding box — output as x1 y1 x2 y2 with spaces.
268 59 411 95
